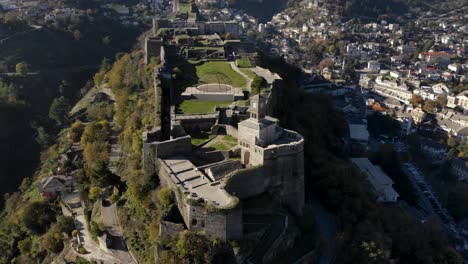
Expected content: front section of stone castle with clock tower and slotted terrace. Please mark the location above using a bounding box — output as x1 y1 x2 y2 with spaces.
143 95 304 240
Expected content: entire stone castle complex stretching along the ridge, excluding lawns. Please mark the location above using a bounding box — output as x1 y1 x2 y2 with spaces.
143 2 305 240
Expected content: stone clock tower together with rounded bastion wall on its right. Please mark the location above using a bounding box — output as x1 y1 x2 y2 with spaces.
238 95 304 215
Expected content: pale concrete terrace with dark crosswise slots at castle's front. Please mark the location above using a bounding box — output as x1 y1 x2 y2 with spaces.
162 156 235 208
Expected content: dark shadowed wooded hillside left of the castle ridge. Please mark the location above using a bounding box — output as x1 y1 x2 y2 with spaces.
0 19 144 204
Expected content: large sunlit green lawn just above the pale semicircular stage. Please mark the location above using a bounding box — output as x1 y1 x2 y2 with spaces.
196 61 247 87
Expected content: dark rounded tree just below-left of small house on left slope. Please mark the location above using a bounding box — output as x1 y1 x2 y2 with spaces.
22 201 55 234
